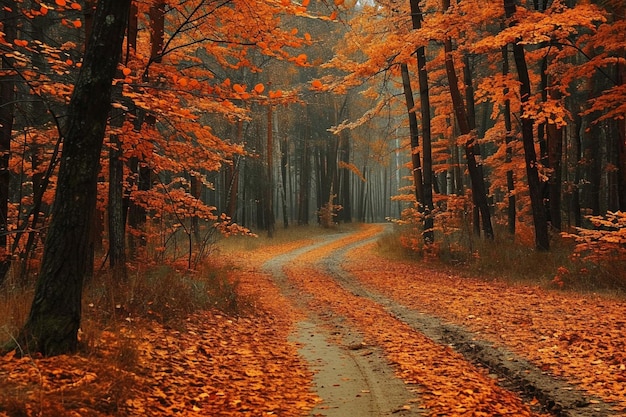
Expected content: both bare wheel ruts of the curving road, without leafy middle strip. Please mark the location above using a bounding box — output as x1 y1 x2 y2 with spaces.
264 224 612 417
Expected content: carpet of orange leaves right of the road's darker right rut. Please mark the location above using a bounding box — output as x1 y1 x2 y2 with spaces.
342 228 626 414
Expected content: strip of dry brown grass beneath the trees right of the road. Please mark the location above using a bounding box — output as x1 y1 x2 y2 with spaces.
386 221 626 297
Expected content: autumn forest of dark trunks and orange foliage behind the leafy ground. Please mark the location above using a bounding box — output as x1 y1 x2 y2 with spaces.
0 0 626 396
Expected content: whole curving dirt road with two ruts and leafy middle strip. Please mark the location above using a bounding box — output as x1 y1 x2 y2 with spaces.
264 226 620 417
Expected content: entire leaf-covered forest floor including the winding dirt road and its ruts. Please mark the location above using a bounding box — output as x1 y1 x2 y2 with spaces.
0 225 626 417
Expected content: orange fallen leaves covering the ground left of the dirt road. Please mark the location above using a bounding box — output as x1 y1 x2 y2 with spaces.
0 236 318 417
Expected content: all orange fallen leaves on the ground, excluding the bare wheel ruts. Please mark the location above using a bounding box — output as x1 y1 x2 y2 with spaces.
0 226 626 417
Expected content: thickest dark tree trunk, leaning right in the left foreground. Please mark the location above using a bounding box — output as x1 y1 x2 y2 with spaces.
11 0 131 356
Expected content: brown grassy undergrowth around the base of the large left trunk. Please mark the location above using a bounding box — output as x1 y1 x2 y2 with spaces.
0 265 241 417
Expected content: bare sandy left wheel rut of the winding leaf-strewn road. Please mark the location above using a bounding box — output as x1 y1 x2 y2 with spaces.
263 235 425 417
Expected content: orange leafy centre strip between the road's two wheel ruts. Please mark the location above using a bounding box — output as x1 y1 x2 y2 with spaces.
285 226 540 416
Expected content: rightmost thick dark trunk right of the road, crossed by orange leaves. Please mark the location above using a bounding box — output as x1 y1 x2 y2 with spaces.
504 0 550 251
